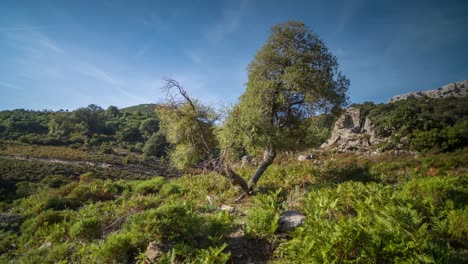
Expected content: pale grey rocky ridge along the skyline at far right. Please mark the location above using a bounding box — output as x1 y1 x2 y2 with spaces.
388 80 468 103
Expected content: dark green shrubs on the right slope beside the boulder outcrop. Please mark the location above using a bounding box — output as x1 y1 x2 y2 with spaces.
354 97 468 151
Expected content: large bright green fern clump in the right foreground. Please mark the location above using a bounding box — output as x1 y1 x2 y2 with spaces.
279 182 456 263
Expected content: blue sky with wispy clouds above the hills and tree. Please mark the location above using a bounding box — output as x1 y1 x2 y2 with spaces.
0 0 468 110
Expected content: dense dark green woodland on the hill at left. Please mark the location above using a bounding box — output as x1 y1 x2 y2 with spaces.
0 105 168 157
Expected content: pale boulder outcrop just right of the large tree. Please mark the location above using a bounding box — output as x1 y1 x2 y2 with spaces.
320 107 384 153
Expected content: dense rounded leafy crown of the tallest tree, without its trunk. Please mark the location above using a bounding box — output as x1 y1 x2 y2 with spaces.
220 21 349 157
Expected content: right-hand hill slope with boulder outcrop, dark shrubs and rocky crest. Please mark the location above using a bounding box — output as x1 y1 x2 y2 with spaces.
321 81 468 155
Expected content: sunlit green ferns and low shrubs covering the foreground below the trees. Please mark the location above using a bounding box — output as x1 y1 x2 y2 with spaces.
0 147 468 263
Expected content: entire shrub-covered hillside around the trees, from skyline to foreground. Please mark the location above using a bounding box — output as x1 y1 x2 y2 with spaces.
0 83 468 263
